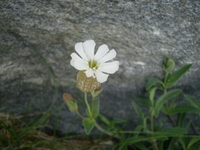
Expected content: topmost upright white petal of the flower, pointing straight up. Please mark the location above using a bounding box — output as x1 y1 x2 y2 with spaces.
83 40 96 59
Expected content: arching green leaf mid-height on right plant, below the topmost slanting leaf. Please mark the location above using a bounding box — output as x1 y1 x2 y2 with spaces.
154 89 182 115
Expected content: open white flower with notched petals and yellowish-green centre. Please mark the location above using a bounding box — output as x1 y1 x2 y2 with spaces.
70 40 119 83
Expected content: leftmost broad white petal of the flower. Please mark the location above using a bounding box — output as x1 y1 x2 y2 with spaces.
70 53 89 70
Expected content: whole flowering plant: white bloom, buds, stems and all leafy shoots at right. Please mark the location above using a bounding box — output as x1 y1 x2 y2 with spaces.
63 40 200 150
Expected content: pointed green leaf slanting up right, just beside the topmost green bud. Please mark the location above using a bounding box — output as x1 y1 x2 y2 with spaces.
165 64 192 88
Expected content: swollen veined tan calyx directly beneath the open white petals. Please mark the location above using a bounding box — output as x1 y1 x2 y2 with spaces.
77 71 101 93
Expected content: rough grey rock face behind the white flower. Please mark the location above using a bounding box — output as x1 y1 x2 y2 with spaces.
0 0 200 133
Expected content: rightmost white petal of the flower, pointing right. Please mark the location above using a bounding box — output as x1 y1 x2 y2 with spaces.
99 61 119 74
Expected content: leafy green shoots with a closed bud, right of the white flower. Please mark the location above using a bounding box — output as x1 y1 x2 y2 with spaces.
119 58 200 150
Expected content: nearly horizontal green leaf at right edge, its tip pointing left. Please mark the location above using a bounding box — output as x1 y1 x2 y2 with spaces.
168 104 200 114
